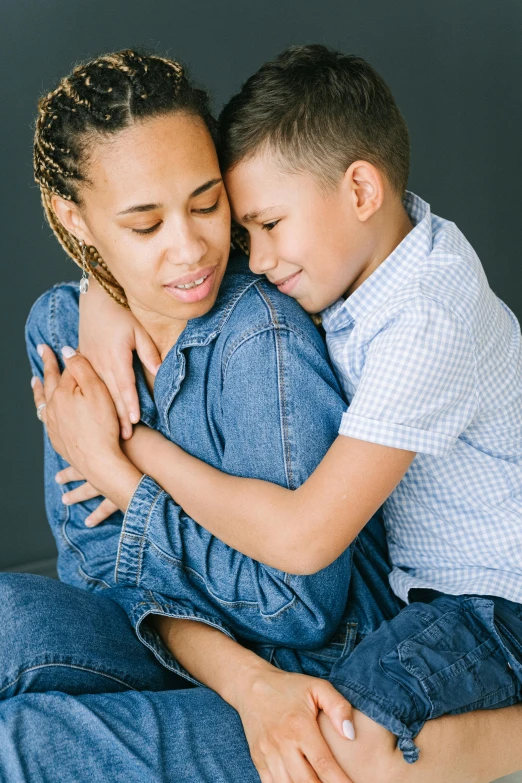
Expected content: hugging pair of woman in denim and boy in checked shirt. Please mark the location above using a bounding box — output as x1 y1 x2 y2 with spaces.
0 45 522 783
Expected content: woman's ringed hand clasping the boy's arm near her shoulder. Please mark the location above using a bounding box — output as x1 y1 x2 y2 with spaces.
31 345 141 510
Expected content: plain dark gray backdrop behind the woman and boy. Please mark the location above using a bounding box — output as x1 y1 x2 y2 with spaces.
0 0 522 570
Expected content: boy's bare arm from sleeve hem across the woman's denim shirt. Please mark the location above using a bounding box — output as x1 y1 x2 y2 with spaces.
124 426 415 574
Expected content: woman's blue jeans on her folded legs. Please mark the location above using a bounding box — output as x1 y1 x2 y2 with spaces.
0 574 259 783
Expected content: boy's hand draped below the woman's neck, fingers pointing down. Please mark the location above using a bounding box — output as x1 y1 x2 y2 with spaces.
80 280 161 438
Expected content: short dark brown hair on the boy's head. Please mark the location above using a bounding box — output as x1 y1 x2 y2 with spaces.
219 44 410 195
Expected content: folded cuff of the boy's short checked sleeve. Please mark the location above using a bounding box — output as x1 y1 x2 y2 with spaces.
339 410 457 457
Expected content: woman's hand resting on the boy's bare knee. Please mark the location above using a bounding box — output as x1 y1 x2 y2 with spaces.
233 667 354 783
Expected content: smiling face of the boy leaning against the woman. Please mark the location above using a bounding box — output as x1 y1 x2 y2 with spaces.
225 152 373 313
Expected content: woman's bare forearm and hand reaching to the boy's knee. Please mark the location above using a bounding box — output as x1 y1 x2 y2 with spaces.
149 615 351 783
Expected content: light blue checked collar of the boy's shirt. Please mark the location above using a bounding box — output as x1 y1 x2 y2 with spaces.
321 191 433 332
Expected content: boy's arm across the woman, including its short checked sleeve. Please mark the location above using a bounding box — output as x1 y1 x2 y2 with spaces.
122 299 477 574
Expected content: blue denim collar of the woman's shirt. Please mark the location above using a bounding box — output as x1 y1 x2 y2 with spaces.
134 251 256 431
